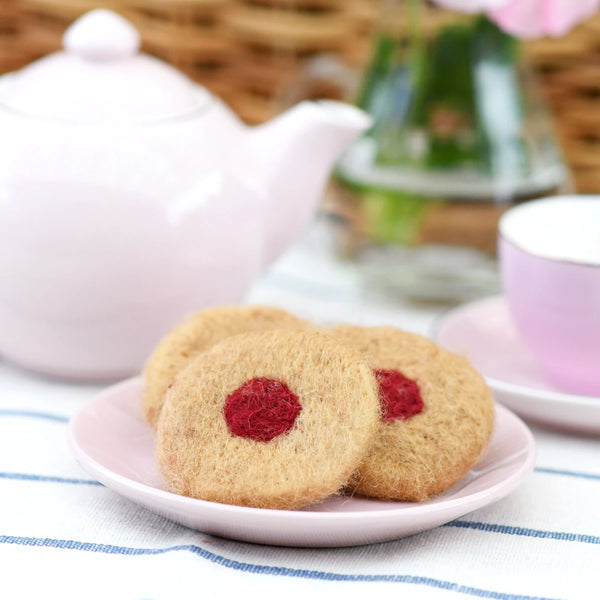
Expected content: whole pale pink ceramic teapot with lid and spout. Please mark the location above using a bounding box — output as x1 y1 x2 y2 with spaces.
0 10 370 379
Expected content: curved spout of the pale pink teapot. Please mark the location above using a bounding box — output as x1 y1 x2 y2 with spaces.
245 100 372 264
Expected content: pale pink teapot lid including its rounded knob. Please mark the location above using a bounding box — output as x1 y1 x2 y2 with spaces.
0 9 211 122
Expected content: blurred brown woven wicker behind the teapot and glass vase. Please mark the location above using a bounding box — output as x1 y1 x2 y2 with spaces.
0 0 600 193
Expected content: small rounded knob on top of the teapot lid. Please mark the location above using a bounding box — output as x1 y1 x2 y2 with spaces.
63 8 140 61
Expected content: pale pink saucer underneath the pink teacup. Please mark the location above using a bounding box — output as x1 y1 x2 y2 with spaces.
433 297 600 433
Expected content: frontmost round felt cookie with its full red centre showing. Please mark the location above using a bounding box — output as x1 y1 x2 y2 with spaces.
156 330 379 509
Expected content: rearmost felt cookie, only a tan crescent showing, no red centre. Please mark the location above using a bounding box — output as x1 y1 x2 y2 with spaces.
142 306 311 427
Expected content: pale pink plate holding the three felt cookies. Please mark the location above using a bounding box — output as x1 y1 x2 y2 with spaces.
69 378 535 547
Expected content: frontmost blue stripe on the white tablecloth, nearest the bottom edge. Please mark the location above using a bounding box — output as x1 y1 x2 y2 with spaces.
0 535 558 600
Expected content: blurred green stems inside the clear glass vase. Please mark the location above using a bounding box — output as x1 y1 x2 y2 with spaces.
338 7 530 244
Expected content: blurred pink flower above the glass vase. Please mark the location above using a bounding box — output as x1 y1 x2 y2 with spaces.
435 0 600 38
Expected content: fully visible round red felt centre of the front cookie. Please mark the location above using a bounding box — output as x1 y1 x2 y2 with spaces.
224 377 302 442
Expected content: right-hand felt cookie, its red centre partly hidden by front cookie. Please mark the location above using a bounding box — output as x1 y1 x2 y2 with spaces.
330 325 494 502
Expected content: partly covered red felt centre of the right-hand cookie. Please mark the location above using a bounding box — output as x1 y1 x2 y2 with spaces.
374 369 423 422
